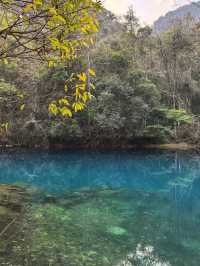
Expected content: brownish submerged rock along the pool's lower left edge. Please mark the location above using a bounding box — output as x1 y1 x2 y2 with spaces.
0 185 28 265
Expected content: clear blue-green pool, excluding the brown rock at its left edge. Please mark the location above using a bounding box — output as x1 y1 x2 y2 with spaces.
0 151 200 266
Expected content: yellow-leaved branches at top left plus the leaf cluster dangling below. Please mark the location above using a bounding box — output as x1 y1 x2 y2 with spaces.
0 0 101 116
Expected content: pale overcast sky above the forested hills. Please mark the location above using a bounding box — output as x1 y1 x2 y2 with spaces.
103 0 195 24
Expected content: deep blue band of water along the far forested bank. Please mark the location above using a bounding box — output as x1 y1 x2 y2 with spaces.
0 151 200 193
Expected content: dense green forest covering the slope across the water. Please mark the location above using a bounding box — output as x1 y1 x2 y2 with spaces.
0 8 200 148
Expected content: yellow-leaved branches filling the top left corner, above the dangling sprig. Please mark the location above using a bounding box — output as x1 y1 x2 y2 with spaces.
0 0 100 60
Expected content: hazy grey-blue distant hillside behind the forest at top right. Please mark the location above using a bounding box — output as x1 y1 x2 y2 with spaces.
154 1 200 32
